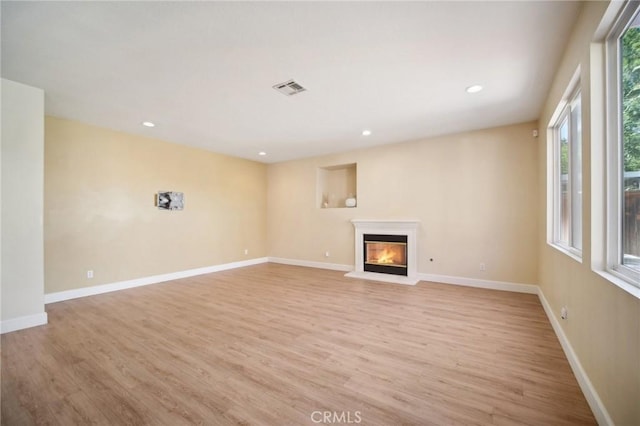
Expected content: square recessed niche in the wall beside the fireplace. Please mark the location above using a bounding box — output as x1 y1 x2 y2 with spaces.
317 163 358 209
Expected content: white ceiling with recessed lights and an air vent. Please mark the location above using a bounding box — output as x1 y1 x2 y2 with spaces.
1 1 580 162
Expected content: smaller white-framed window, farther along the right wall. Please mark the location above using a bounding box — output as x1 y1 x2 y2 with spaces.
549 82 582 260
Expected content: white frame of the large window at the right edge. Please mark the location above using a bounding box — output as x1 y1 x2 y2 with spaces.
604 2 640 295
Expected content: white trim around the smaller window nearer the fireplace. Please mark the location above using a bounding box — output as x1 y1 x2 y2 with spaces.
547 67 584 263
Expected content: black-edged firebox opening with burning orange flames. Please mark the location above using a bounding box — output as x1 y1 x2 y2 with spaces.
363 234 407 277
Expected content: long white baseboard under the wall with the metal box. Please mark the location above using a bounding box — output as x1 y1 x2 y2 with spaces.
44 257 268 304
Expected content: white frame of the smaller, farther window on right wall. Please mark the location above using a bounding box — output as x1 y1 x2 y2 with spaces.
547 78 584 263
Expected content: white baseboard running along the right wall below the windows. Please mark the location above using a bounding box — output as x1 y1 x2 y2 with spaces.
538 287 614 426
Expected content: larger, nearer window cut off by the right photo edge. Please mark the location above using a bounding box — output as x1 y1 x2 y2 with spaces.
606 3 640 287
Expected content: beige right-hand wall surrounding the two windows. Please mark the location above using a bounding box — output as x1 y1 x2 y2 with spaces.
538 2 640 425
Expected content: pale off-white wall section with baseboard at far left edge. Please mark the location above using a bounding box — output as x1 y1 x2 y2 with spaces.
1 79 46 331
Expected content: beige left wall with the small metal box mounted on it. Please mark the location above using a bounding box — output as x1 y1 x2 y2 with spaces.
44 117 266 293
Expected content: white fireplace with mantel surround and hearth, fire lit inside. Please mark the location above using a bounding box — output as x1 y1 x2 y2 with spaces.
345 219 419 285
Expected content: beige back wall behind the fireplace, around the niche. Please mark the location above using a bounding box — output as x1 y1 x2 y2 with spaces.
267 123 538 284
